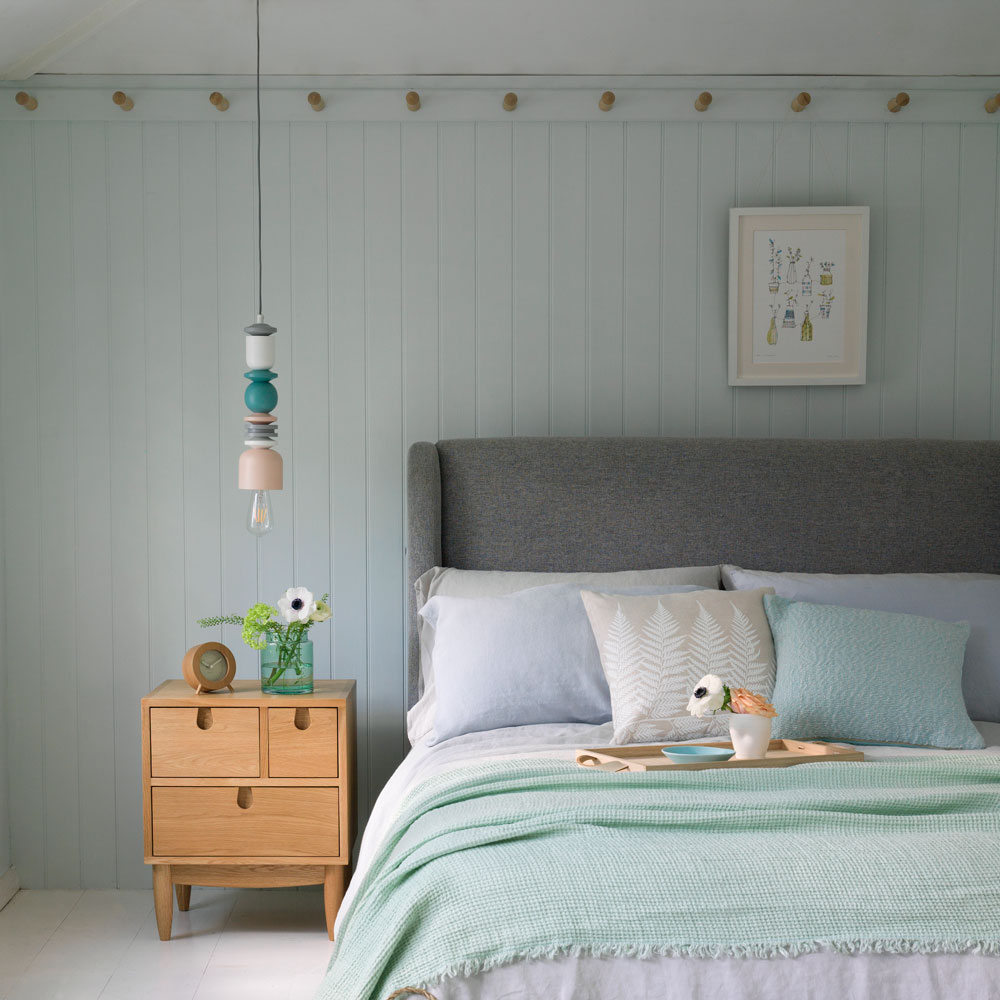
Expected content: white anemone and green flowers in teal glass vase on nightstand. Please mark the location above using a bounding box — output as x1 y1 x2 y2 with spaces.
198 587 333 694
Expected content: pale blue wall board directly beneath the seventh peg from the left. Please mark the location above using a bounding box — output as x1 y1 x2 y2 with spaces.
587 122 625 435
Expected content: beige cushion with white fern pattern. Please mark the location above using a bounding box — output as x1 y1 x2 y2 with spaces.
580 587 774 743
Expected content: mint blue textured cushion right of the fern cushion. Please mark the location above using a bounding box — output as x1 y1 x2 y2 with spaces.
764 594 985 750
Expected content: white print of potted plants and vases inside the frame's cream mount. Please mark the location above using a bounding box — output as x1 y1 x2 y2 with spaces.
753 229 847 364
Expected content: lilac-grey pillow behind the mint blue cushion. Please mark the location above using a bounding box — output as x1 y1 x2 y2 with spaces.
722 566 1000 722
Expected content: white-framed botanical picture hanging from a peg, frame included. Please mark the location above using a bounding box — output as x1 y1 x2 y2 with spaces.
729 207 868 385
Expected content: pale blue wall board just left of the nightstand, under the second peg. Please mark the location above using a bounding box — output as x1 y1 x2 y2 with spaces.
107 122 151 886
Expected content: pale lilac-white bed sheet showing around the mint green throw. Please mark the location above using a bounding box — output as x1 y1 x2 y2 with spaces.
337 722 1000 1000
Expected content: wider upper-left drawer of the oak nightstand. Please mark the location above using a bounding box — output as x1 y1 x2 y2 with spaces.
149 706 260 778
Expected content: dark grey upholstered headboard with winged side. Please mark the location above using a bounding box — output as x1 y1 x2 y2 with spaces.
407 438 1000 705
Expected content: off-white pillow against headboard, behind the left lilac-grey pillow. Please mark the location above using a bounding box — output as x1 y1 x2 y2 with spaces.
406 566 720 745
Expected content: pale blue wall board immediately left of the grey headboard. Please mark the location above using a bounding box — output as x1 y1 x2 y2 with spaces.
365 124 405 788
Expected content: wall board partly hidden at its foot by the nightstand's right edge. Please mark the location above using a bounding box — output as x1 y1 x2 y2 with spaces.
327 123 371 816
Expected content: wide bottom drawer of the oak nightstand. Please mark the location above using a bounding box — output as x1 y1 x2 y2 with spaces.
151 785 340 858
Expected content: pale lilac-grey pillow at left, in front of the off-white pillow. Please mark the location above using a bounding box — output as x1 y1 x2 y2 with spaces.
420 583 701 743
